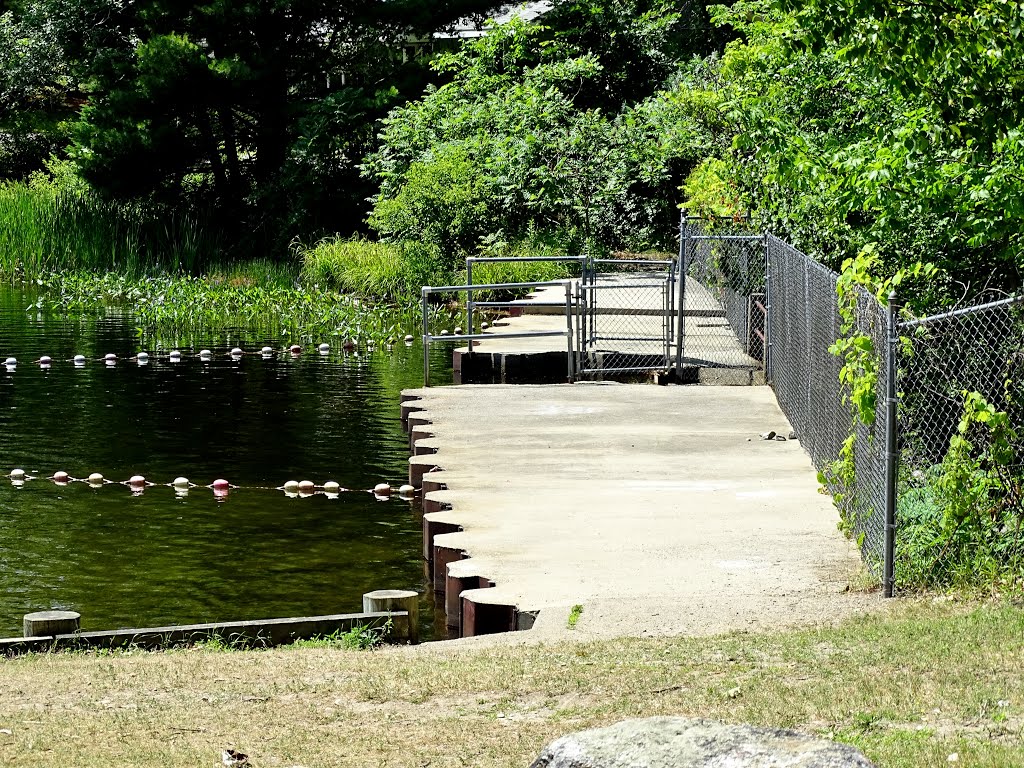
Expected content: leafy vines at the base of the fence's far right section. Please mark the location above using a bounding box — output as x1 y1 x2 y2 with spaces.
896 391 1024 590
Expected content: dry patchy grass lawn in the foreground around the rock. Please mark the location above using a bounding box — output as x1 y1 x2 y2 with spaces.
0 600 1024 768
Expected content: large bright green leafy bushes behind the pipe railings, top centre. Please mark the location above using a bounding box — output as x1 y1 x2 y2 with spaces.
365 0 729 257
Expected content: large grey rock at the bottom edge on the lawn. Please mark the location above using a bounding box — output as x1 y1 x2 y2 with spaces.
530 718 874 768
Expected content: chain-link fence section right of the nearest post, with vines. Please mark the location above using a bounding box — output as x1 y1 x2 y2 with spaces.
894 297 1024 588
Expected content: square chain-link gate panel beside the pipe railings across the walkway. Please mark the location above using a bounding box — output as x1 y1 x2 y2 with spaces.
575 259 677 379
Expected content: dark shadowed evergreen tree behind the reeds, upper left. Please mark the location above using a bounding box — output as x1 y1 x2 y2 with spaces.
4 0 507 246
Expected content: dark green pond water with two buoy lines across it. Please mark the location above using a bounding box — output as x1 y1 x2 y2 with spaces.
0 288 451 637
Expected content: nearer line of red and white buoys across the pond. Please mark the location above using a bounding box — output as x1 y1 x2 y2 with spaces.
3 468 416 501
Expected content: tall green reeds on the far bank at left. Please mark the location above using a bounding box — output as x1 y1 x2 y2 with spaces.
0 182 222 279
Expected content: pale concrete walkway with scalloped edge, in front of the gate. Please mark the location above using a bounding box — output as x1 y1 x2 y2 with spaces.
403 383 877 637
